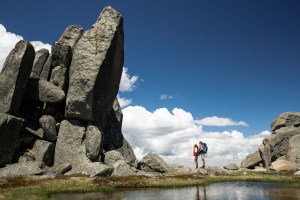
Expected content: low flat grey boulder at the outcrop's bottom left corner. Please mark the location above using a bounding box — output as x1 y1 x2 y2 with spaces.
0 161 44 178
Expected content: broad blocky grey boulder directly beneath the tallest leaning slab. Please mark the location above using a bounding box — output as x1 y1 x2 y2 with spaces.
54 120 91 170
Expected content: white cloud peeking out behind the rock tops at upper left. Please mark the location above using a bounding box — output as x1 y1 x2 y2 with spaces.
0 24 51 71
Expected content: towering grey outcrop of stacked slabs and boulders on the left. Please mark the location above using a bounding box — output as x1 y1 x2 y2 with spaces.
0 7 137 177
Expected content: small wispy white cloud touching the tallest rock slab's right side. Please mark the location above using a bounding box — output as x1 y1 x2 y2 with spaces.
120 67 139 92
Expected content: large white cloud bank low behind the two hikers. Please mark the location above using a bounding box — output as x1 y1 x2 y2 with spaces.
122 106 270 167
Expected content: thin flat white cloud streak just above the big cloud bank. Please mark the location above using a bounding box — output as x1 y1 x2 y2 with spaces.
195 116 249 126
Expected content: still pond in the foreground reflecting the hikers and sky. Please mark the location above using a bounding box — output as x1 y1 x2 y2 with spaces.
51 182 300 200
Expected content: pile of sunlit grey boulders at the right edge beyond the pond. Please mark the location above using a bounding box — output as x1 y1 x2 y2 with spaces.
241 112 300 170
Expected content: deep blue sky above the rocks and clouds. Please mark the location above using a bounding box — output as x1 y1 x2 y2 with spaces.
0 0 300 166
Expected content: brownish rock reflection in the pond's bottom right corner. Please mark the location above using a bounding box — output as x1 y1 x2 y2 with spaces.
266 188 300 200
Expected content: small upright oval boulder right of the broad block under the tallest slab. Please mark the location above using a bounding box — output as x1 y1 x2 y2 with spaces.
85 124 103 161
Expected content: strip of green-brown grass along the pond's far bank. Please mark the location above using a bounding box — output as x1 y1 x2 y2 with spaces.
0 172 300 200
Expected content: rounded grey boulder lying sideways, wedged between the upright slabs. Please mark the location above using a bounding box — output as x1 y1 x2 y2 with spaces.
26 79 66 103
